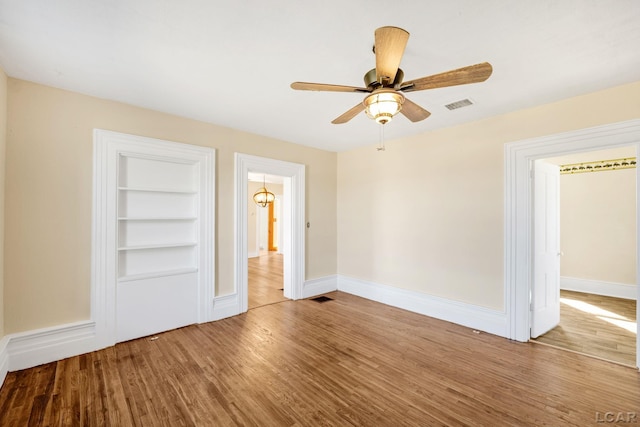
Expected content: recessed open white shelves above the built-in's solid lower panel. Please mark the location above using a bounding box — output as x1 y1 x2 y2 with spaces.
117 156 199 282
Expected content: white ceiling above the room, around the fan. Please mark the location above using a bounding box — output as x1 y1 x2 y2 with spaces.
0 0 640 151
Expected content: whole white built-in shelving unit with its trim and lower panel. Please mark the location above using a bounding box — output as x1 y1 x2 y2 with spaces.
92 129 216 345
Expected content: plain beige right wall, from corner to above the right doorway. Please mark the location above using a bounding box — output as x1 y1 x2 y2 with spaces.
338 82 640 310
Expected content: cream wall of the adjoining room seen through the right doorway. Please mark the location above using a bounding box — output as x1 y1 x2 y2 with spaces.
560 169 636 285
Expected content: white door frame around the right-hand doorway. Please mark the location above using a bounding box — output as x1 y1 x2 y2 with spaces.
504 119 640 366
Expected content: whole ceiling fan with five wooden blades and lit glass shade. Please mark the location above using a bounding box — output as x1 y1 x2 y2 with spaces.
291 27 493 125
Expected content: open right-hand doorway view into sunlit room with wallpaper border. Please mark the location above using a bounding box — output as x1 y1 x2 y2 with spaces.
534 146 638 366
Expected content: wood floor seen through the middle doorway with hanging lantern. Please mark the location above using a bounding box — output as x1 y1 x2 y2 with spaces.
248 251 287 309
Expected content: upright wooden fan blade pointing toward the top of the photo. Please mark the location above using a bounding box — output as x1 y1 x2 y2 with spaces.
375 27 409 85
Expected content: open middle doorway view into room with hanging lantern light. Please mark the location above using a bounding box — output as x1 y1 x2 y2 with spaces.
247 172 288 310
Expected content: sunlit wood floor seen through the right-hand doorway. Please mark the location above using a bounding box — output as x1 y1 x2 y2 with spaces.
535 290 640 366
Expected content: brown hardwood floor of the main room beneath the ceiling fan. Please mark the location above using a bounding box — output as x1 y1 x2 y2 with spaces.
0 292 640 426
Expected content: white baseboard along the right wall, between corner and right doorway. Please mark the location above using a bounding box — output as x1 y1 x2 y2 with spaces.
338 275 507 337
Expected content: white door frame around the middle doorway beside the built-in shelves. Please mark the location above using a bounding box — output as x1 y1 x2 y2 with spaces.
234 153 305 313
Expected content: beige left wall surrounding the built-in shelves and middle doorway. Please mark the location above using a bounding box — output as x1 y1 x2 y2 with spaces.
4 78 337 333
